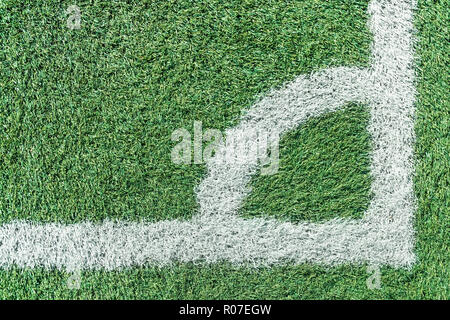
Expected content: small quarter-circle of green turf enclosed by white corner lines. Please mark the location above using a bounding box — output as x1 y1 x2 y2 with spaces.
242 106 371 222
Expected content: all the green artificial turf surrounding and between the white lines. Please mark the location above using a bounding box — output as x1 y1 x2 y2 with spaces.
0 0 450 299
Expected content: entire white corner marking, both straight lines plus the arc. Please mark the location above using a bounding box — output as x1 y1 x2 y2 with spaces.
0 0 415 270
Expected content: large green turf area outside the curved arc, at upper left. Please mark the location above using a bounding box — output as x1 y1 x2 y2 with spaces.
0 0 370 223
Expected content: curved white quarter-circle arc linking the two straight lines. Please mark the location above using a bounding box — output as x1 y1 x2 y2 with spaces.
197 67 369 215
